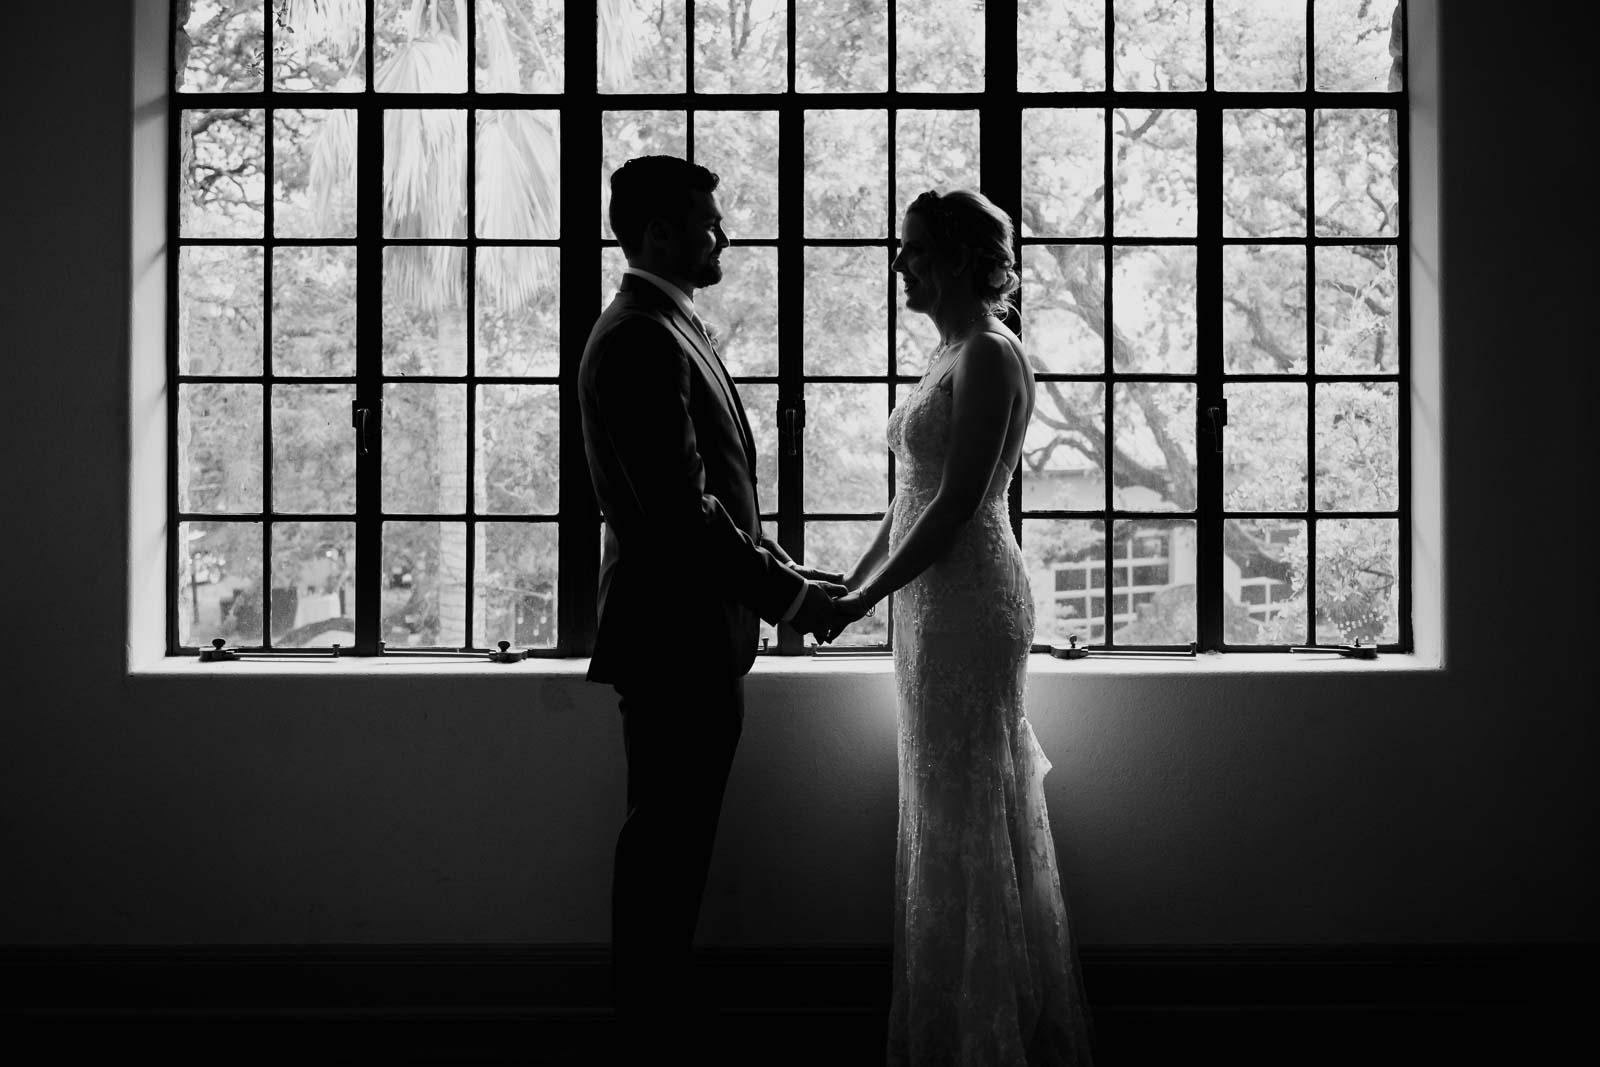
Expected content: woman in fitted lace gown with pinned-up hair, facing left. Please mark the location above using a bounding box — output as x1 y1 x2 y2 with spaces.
835 190 1090 1067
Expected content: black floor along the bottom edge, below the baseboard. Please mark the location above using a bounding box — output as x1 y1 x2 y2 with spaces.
0 1008 1555 1067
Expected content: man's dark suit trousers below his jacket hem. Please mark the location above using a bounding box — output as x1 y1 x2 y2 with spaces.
611 675 744 1051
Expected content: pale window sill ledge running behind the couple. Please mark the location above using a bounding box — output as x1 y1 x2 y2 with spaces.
128 653 1443 681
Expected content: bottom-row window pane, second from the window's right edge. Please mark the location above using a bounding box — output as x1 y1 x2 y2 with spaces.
1222 518 1310 645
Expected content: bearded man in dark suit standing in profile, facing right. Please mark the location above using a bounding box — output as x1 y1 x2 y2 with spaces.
579 155 845 1059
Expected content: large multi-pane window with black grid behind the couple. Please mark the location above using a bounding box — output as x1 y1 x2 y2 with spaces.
170 0 1410 654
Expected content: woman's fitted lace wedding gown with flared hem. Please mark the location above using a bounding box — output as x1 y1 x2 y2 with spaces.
888 347 1090 1067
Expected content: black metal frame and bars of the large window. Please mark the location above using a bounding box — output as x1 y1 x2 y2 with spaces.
166 0 1413 657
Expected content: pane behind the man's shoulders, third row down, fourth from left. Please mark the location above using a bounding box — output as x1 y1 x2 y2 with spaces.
474 246 562 378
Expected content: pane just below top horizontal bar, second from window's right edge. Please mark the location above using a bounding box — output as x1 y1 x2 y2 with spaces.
1222 107 1306 237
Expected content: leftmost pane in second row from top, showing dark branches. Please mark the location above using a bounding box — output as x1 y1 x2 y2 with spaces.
178 107 267 237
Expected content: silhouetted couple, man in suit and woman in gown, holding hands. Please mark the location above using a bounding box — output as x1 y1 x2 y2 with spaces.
579 155 1090 1067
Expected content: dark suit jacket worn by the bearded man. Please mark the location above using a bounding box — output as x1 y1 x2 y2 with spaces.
578 275 803 686
